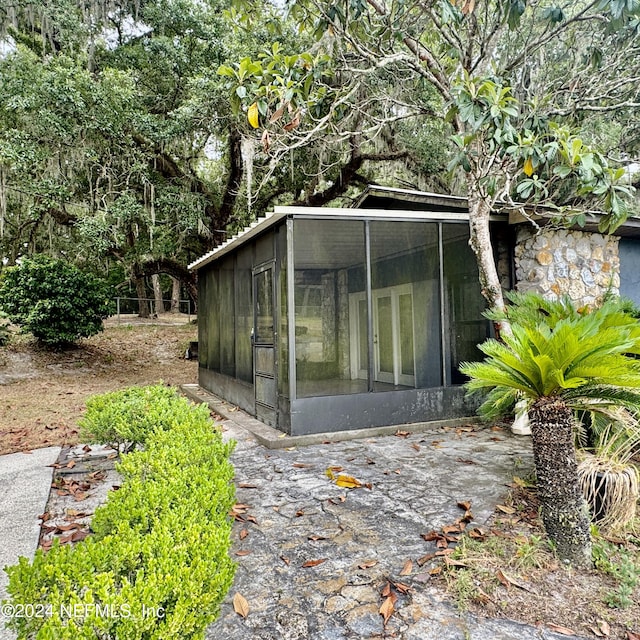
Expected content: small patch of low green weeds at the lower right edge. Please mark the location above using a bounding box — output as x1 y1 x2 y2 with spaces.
592 538 640 609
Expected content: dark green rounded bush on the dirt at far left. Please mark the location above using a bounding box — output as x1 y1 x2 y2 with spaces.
0 255 113 348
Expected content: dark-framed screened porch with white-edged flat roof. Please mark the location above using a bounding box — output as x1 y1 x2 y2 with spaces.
190 202 491 435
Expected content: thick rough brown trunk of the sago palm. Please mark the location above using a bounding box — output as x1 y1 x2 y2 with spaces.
529 397 592 568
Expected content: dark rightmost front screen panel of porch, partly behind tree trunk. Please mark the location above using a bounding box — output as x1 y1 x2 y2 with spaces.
442 224 490 384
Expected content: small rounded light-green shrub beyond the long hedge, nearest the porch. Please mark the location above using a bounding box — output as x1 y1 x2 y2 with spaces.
78 384 195 448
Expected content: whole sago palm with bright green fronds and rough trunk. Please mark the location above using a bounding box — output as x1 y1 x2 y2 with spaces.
461 293 640 566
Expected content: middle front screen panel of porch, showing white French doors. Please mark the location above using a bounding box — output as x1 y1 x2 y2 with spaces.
370 220 442 391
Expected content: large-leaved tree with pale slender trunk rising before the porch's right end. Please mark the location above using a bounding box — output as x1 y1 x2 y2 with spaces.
222 0 640 307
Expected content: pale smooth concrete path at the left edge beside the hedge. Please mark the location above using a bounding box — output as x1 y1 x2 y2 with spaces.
0 447 60 640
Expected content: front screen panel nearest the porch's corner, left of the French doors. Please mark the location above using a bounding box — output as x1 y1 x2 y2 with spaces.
294 220 368 398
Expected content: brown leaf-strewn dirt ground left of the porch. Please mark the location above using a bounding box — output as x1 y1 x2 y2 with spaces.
0 314 198 455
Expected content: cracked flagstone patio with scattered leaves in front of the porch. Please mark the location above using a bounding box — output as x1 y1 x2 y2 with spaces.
207 405 592 640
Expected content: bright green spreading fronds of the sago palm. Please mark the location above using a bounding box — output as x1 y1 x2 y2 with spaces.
460 293 640 418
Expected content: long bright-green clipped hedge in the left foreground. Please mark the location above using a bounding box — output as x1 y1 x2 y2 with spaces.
7 388 234 640
